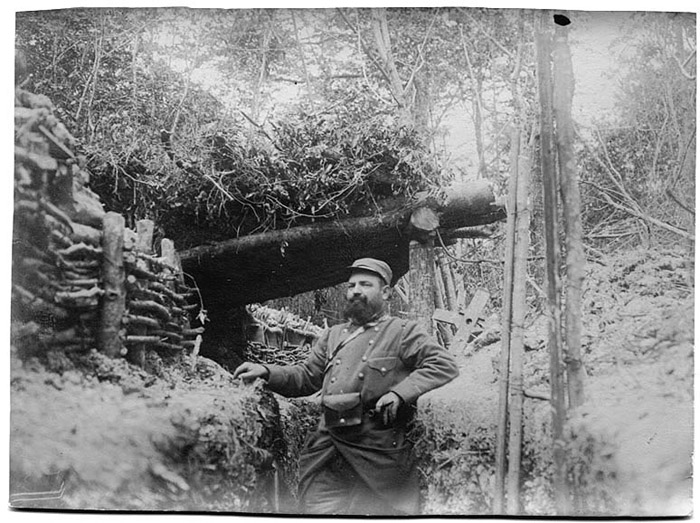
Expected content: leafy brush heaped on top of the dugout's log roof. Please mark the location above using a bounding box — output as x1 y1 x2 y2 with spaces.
87 108 434 247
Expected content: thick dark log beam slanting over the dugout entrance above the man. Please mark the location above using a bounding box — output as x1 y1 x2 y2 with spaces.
180 180 505 310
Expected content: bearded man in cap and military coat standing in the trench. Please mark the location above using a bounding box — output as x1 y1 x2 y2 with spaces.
234 258 458 515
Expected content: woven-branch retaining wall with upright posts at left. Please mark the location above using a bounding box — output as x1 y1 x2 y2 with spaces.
12 89 202 365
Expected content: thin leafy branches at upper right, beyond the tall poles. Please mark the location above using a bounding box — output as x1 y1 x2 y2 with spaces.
579 14 697 250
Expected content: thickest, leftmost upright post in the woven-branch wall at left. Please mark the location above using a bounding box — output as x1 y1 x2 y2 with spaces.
98 212 126 357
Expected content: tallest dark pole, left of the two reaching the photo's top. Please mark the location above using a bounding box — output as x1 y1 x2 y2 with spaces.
535 11 570 516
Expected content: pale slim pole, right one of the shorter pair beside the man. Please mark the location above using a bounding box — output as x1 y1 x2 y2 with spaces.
506 132 530 515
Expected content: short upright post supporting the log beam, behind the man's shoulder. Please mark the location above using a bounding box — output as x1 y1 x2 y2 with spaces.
408 239 435 334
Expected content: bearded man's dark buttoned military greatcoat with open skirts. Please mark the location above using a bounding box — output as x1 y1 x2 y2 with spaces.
268 316 458 514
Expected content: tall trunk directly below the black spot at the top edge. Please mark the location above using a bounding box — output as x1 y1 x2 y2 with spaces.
553 20 586 409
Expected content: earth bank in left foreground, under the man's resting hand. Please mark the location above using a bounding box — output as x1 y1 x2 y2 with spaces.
10 351 286 512
